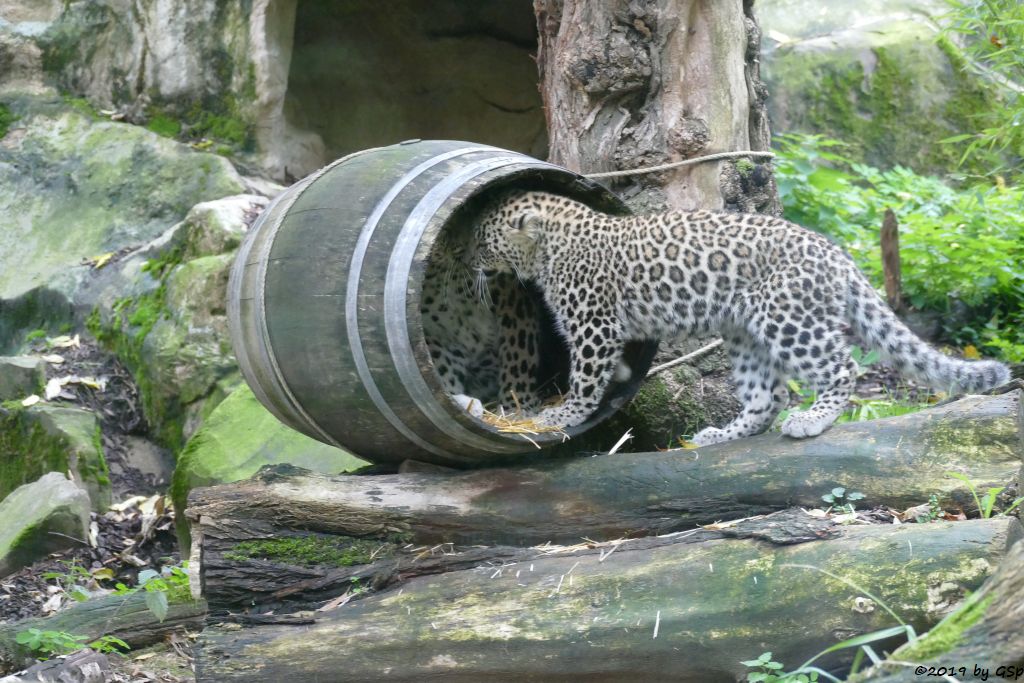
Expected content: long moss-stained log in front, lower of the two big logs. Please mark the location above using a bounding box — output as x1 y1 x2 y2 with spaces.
196 517 1021 683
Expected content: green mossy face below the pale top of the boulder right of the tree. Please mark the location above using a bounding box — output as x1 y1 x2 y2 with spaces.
765 22 999 173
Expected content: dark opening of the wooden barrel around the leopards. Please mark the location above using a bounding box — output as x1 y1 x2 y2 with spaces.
420 175 652 432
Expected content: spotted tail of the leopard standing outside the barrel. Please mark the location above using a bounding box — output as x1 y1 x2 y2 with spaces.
847 267 1010 393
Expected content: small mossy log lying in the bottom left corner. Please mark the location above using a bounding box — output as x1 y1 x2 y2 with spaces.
0 592 206 674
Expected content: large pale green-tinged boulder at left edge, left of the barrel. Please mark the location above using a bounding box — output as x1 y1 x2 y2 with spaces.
0 97 244 349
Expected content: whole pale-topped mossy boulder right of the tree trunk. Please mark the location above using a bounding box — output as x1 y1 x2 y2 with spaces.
756 0 998 174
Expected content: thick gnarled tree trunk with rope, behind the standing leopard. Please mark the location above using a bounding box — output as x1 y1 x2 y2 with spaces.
534 0 781 215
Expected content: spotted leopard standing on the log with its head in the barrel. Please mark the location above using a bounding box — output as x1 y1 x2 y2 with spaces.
469 191 1009 445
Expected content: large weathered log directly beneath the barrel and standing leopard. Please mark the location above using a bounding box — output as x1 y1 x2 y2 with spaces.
186 392 1024 609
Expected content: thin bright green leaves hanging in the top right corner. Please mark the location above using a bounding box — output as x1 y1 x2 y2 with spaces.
942 0 1024 173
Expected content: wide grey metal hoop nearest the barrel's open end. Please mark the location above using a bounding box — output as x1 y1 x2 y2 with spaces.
384 153 558 454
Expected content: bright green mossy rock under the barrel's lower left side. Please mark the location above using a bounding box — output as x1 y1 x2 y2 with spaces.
171 386 367 549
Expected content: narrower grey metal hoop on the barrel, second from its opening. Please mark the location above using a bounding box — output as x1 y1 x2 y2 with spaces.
345 145 499 460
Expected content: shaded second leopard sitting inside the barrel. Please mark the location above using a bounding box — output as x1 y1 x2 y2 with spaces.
420 230 541 417
